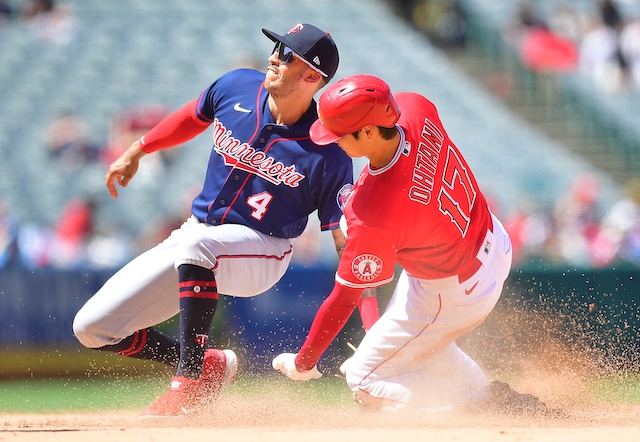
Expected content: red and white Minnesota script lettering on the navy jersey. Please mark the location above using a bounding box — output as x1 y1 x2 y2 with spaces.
213 118 305 187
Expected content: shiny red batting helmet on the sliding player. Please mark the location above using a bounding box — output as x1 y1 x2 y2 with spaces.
309 75 400 145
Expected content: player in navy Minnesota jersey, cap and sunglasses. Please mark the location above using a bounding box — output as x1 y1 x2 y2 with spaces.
73 24 377 416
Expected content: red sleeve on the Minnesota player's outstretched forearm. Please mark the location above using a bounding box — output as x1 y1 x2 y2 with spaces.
142 100 210 153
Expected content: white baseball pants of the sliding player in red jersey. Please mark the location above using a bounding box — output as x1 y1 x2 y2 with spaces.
346 217 511 411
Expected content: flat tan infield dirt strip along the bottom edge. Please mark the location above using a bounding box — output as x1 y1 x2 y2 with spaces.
0 398 640 442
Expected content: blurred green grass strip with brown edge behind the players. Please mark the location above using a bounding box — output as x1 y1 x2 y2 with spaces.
0 350 640 413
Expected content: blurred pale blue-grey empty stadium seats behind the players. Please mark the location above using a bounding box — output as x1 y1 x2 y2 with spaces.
0 0 615 235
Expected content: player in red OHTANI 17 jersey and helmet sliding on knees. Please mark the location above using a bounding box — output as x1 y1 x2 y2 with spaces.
273 75 540 410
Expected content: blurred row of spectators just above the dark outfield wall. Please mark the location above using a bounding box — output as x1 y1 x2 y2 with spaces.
0 175 640 269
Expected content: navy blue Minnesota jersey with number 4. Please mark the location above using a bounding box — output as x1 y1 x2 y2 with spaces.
192 69 353 238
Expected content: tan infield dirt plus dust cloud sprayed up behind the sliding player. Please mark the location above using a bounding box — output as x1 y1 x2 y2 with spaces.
0 302 640 442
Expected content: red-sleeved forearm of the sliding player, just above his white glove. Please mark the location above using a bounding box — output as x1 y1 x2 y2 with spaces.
296 283 362 371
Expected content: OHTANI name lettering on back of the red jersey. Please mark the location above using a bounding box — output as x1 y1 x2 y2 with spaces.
409 118 444 205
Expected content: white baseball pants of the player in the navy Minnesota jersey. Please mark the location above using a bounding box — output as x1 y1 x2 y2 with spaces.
73 217 293 348
